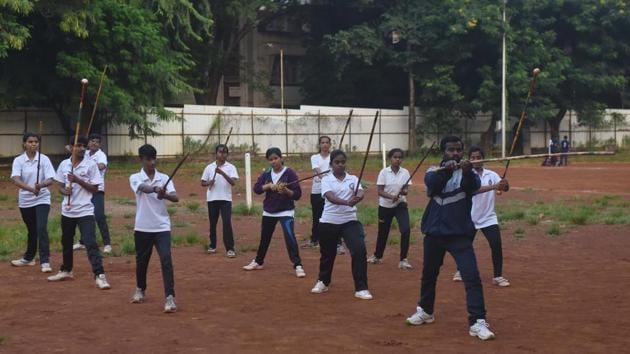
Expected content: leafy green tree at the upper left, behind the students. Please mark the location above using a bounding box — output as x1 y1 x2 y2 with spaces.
1 0 192 136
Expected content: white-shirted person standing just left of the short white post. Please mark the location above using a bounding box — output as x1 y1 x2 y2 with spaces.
201 144 238 258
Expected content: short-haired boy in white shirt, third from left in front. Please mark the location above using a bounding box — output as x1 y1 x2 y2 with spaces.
129 144 179 313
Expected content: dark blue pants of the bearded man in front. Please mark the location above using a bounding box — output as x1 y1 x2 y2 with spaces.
418 235 486 325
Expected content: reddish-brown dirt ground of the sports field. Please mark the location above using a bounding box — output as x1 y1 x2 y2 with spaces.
0 163 630 353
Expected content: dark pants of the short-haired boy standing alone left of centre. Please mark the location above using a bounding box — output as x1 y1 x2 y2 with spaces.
133 231 175 297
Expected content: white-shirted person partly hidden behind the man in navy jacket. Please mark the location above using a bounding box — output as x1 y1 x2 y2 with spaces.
453 146 510 287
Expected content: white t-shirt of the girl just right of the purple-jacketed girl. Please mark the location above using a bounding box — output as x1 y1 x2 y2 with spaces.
319 172 363 225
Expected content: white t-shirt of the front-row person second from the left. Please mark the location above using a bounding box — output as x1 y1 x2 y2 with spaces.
55 156 103 218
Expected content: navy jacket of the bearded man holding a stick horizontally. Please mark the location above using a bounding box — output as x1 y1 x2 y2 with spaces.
421 161 481 236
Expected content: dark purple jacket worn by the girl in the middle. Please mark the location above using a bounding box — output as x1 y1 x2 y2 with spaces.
254 167 302 213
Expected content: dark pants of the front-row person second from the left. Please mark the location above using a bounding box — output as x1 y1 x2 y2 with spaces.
61 215 105 275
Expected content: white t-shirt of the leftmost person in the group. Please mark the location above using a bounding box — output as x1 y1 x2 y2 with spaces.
11 152 55 208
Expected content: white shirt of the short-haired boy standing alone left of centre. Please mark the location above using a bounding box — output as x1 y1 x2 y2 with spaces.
129 169 175 232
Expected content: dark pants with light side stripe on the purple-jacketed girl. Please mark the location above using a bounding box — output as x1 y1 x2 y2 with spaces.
256 216 302 267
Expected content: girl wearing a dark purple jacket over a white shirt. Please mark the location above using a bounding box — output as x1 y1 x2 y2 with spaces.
243 147 306 278
